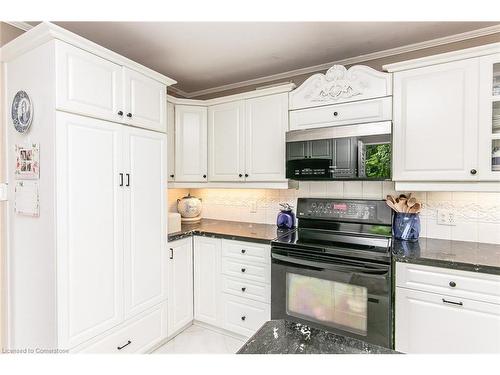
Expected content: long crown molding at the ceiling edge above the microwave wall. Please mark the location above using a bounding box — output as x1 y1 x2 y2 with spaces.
176 24 500 99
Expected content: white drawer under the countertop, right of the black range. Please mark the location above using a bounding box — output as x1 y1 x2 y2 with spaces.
396 263 500 304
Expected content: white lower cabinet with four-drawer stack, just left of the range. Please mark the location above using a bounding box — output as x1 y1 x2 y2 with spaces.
194 236 271 337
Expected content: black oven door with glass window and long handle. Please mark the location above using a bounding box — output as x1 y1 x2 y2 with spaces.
271 247 392 348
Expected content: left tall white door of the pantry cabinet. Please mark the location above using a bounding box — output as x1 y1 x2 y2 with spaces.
55 112 124 348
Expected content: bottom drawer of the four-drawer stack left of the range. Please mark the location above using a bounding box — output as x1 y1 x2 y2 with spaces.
222 293 271 336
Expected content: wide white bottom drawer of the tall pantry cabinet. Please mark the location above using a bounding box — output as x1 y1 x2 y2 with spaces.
79 304 167 354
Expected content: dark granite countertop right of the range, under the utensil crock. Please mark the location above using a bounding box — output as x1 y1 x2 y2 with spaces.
392 237 500 275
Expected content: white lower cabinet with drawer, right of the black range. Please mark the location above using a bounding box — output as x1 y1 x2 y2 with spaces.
395 263 500 353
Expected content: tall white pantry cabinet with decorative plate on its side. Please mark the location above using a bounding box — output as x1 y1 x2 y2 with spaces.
2 23 174 353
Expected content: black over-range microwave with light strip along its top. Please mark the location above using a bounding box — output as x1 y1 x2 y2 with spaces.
286 122 392 181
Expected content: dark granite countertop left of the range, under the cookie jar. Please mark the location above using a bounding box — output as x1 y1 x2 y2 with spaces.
168 219 294 244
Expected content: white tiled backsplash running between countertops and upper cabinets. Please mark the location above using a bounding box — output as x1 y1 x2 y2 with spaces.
169 181 500 244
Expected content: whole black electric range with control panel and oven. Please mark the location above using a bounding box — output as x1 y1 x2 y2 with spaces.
271 198 392 348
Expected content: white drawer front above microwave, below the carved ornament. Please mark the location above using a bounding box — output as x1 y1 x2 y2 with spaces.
290 97 392 130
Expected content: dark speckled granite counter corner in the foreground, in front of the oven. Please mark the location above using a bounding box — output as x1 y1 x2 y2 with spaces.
237 320 398 354
